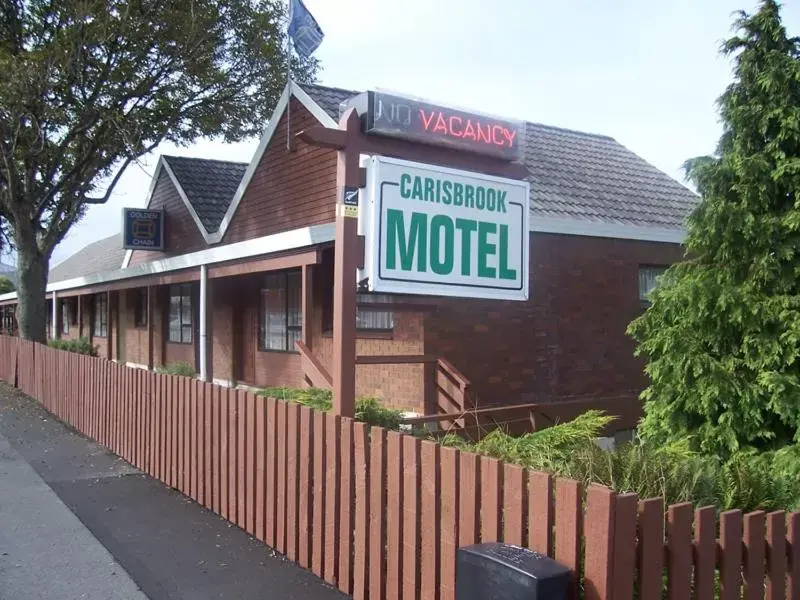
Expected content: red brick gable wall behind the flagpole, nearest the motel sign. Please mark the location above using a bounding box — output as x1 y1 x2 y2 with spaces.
223 98 336 243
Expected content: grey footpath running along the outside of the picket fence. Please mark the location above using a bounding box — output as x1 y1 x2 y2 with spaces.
0 384 346 600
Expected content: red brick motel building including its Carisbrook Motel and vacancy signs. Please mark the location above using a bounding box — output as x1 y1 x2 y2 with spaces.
0 83 697 424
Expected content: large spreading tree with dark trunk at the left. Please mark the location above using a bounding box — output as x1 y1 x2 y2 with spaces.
0 0 317 341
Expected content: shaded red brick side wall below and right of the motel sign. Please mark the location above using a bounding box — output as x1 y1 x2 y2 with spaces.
425 234 681 403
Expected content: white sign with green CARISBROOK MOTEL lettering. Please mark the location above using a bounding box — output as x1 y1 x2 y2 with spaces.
362 156 530 300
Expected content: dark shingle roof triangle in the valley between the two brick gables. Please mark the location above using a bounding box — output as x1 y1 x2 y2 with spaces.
162 156 247 233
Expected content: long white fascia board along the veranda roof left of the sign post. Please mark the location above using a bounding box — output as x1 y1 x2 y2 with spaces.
0 223 336 302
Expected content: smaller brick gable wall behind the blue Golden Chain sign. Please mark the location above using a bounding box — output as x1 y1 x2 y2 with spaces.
130 169 206 265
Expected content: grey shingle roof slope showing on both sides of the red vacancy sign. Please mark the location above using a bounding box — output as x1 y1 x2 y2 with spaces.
301 84 698 229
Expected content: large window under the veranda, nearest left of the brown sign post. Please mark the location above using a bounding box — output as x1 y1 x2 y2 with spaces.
259 271 303 352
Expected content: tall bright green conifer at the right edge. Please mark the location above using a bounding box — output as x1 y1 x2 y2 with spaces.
629 0 800 457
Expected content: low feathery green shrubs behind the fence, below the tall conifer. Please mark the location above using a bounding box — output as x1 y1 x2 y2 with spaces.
440 411 800 512
